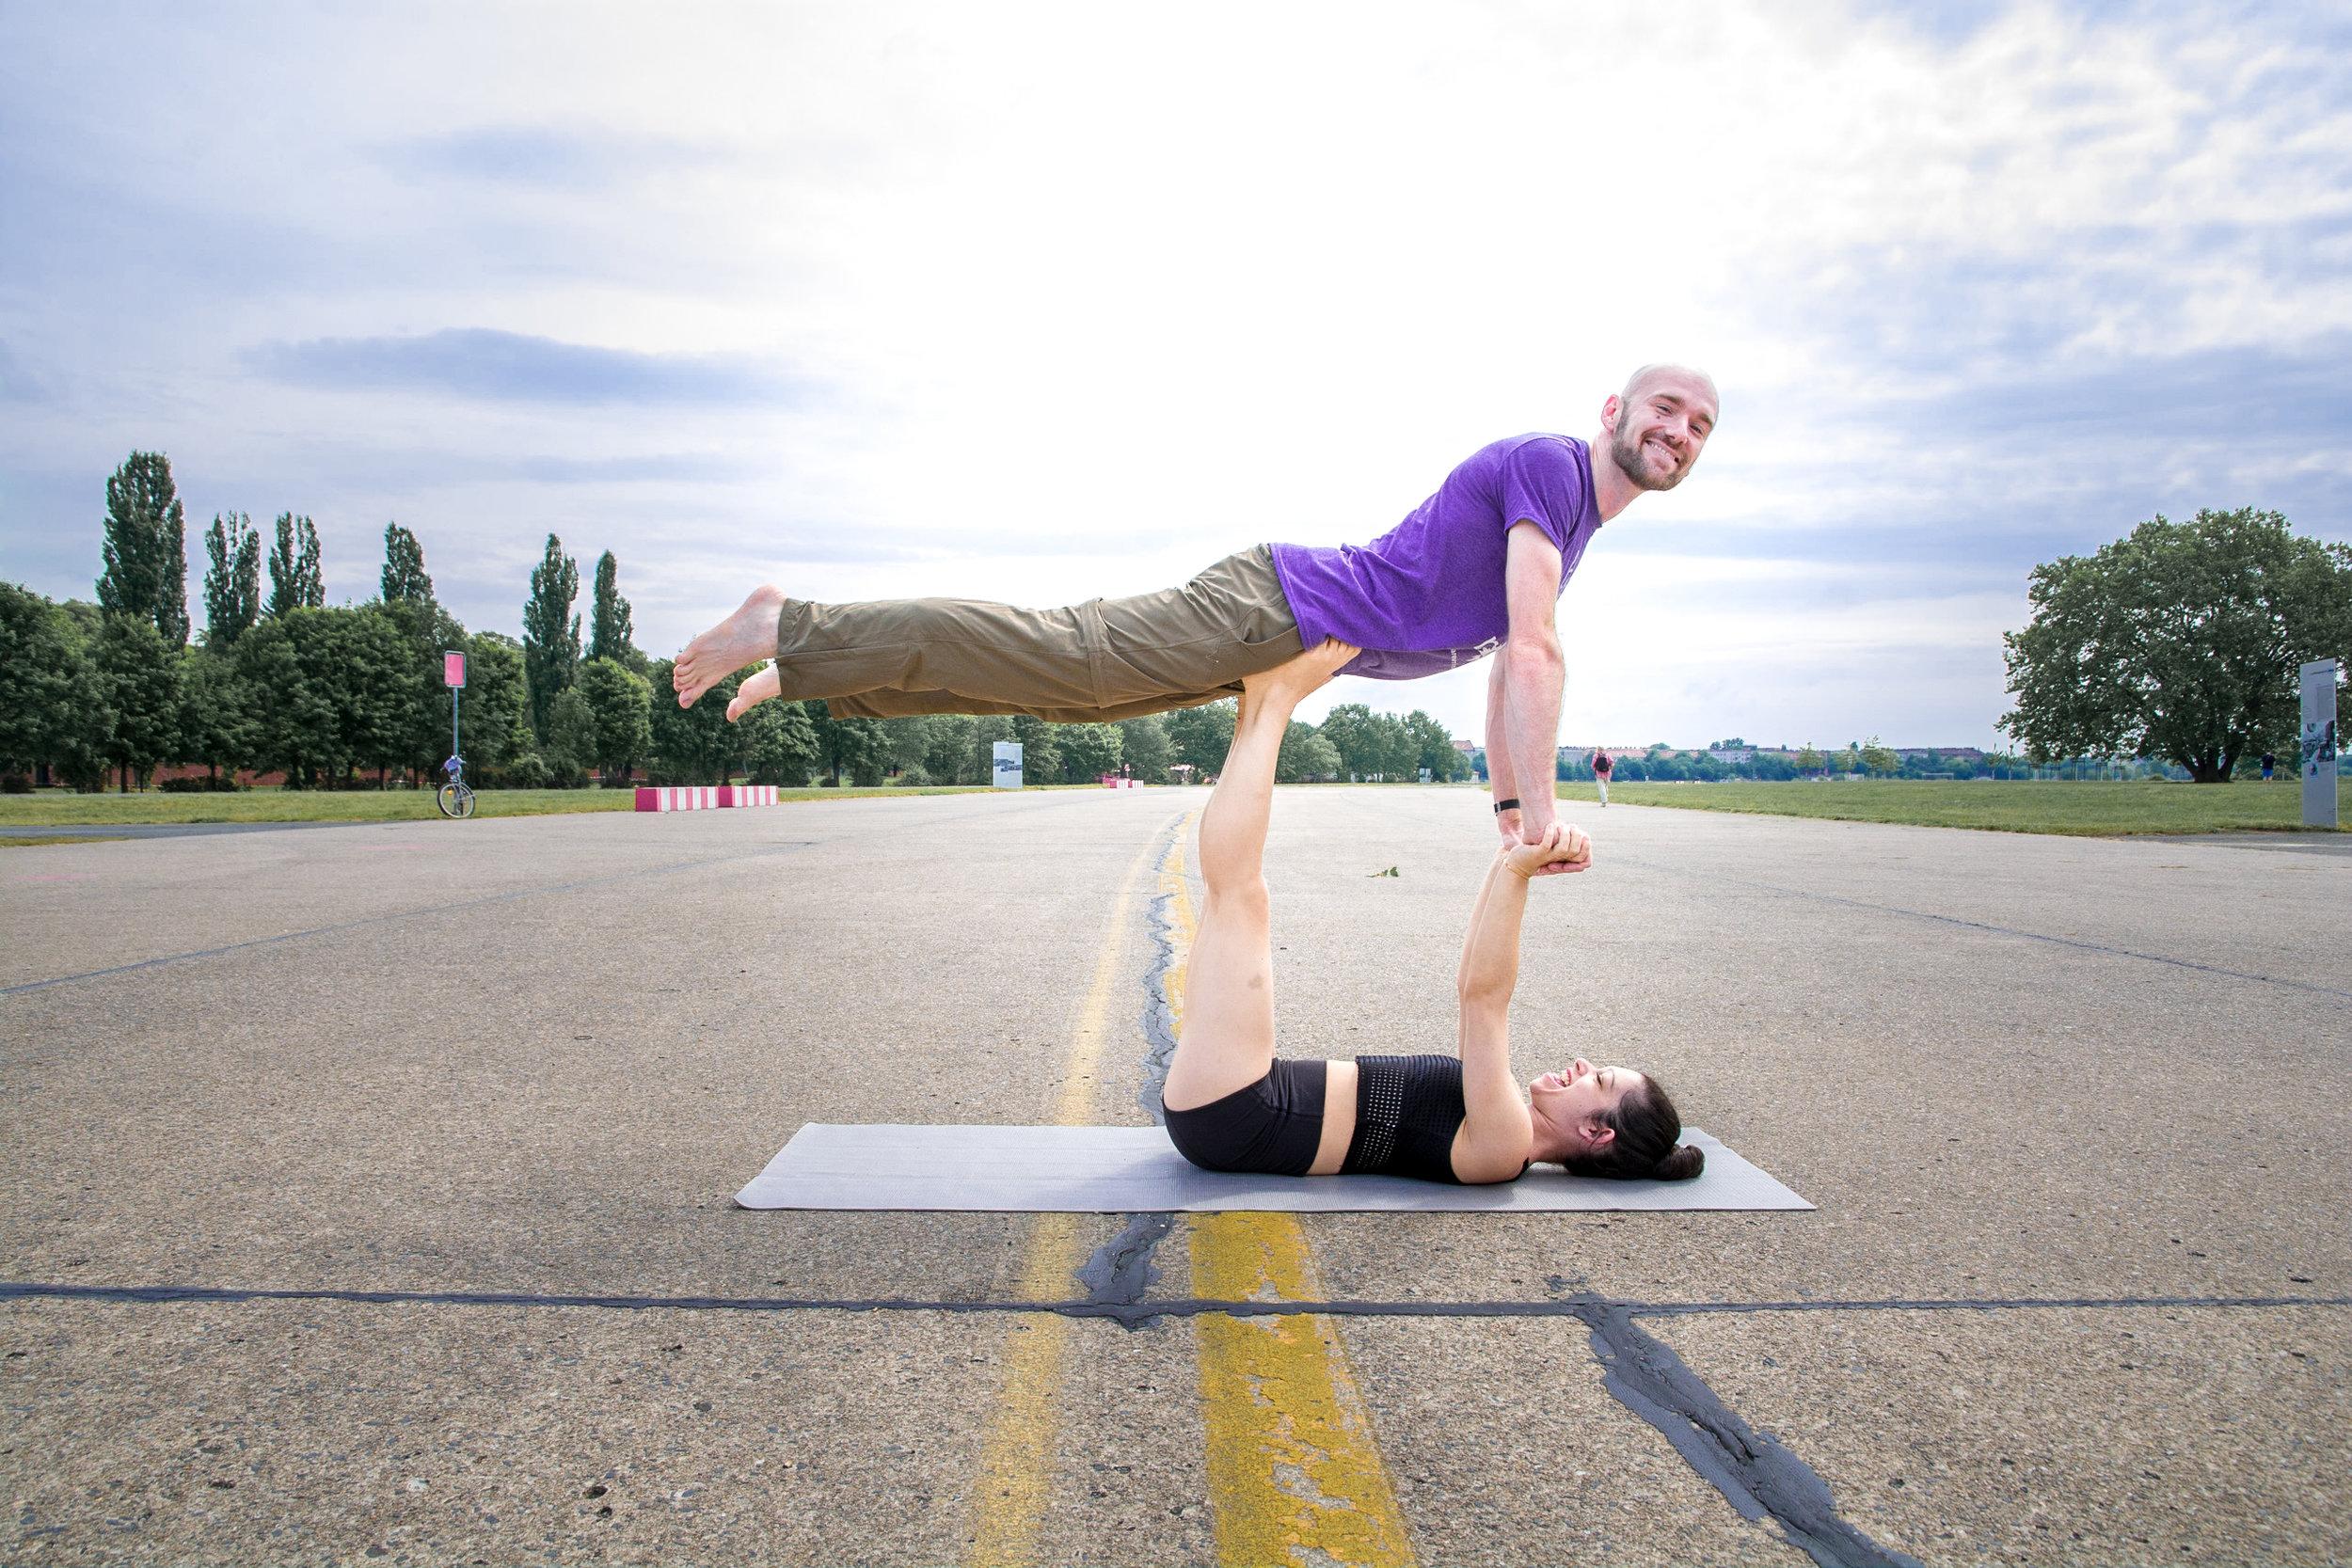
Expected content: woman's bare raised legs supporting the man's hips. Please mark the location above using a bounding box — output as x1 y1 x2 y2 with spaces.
1162 641 1358 1110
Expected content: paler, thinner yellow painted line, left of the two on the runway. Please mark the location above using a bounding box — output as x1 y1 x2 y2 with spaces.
964 834 1181 1568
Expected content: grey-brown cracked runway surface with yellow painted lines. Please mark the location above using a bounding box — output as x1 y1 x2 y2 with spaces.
0 787 2352 1563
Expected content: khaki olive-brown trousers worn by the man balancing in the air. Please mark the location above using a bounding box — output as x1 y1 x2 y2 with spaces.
776 546 1301 724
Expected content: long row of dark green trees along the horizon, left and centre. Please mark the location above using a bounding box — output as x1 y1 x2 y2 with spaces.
0 451 1470 792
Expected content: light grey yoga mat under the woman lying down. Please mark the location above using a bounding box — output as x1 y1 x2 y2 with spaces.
737 1121 1811 1213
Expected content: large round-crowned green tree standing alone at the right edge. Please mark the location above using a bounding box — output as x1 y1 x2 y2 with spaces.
1999 508 2352 783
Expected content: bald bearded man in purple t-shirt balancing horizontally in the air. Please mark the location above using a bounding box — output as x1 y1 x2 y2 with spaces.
673 364 1717 844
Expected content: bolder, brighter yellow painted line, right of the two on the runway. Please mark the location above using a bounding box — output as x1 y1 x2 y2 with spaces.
1160 823 1414 1568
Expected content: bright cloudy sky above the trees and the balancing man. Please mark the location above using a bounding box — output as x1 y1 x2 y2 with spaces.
0 0 2352 745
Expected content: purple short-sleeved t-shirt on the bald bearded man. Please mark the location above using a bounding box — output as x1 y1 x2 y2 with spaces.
1273 435 1602 679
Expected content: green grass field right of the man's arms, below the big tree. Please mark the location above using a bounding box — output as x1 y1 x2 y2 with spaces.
1560 778 2352 837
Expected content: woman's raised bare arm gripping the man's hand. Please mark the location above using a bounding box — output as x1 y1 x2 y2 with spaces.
1454 823 1593 1182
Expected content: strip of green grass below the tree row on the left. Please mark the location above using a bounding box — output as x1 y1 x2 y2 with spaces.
0 785 983 844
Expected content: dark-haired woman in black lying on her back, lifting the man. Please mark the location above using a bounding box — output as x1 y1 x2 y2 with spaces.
1160 641 1706 1182
